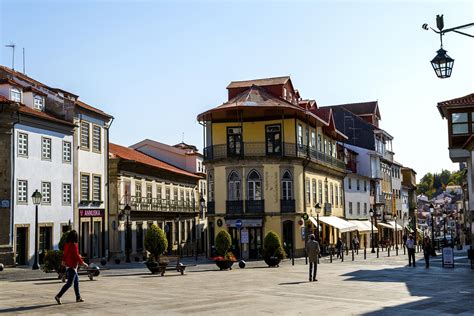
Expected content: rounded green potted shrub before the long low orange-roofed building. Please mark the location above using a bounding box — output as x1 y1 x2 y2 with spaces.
145 225 168 273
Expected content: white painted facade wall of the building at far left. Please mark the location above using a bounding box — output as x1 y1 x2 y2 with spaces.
13 124 74 264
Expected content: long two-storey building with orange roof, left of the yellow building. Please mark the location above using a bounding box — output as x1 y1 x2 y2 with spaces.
109 144 201 258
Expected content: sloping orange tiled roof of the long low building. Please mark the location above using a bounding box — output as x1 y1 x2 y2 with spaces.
109 143 201 179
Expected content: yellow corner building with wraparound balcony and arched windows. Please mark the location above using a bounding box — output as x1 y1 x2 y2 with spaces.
197 77 356 259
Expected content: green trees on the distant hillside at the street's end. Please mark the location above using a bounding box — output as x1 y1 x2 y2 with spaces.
416 169 466 199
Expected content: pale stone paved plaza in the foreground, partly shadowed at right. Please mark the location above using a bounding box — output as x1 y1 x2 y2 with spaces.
0 251 474 315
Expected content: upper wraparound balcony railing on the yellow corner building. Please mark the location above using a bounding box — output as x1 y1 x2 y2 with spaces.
204 142 346 170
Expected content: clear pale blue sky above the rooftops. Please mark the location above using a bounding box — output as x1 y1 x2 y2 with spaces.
0 0 474 178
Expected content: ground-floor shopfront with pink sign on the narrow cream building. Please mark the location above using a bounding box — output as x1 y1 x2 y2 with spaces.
78 209 106 259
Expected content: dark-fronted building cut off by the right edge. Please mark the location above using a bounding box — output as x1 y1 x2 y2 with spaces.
438 93 474 251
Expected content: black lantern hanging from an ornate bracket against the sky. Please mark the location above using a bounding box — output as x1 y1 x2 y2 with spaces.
422 15 474 79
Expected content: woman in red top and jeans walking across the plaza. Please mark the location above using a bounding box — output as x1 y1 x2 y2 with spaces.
54 230 87 305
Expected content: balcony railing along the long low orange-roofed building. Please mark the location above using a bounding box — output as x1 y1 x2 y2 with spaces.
127 196 199 212
